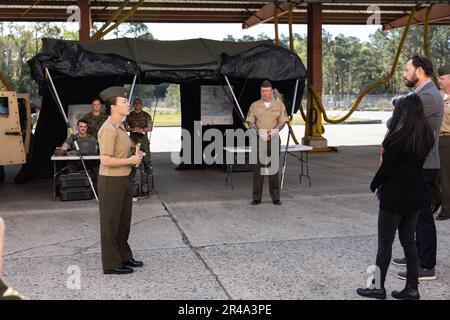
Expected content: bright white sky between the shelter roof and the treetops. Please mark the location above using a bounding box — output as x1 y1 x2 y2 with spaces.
143 23 381 41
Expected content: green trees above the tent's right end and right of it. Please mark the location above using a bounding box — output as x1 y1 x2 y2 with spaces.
224 26 450 97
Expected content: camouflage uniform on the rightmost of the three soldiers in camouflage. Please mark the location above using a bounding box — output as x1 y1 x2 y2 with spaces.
125 110 153 189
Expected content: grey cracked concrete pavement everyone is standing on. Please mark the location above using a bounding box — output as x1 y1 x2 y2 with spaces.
0 121 450 299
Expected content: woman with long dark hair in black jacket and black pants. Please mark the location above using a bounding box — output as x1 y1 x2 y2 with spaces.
357 93 434 299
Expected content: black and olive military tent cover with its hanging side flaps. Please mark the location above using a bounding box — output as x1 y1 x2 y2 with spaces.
24 38 306 178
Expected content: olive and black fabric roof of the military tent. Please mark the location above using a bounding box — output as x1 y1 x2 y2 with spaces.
29 38 306 84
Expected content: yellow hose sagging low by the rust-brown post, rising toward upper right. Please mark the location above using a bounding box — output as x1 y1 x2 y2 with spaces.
308 7 416 124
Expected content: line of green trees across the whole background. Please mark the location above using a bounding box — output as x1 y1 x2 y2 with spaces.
0 22 450 102
